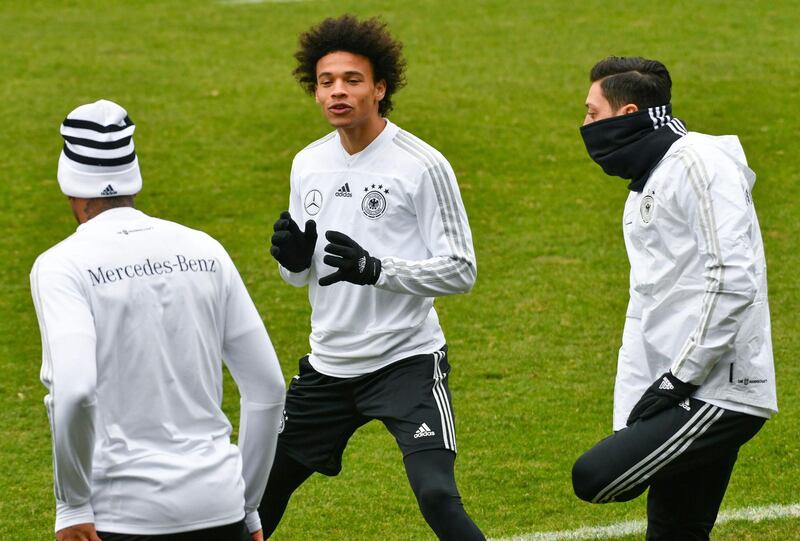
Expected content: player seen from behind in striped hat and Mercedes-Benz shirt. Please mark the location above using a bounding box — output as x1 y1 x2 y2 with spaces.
31 100 285 541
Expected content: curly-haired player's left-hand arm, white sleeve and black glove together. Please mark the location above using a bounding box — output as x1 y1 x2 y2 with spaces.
269 164 317 287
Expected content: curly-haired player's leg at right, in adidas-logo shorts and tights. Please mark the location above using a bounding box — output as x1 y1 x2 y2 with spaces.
356 347 485 541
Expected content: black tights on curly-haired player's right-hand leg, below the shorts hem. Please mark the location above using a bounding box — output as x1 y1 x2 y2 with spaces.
403 449 486 541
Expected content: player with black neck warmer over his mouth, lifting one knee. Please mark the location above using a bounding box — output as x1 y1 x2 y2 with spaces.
572 57 777 541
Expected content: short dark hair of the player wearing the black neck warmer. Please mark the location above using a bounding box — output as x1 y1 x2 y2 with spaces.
589 56 672 109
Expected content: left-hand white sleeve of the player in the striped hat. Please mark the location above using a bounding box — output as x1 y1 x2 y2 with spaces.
30 255 97 531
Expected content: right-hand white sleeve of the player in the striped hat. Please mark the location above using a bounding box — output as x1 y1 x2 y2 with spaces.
222 263 286 532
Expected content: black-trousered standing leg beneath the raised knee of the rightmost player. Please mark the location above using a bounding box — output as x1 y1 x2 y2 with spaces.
647 450 738 541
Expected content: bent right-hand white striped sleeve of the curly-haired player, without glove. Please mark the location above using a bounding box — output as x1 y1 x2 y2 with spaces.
375 159 477 297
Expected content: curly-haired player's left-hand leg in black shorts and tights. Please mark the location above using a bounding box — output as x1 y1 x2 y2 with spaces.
258 357 369 538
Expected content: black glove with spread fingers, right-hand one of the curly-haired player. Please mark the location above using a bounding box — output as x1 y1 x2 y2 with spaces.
319 231 381 286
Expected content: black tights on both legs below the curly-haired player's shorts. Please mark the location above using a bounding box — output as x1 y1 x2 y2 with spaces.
258 447 486 541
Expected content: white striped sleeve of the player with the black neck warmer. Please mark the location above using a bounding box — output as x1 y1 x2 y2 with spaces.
671 148 757 385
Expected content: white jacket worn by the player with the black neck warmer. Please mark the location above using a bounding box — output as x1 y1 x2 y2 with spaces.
614 133 777 430
